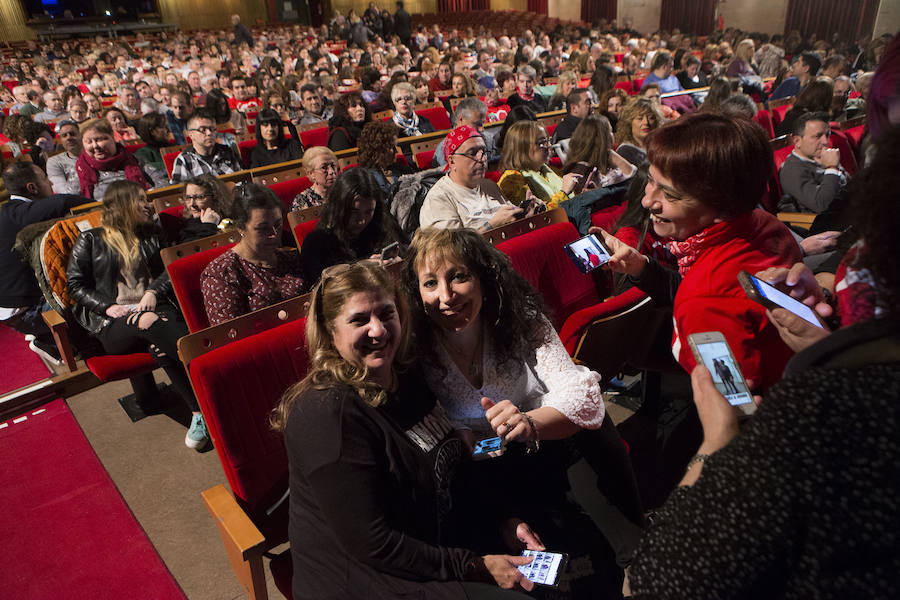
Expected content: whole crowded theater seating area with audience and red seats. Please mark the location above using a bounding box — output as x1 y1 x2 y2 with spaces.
0 1 900 600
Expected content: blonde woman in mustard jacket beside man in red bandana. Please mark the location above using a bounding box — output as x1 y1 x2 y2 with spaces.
498 120 582 209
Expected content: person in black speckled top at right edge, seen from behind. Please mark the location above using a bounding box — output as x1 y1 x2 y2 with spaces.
630 122 900 598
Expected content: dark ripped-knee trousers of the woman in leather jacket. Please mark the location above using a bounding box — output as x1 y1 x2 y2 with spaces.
97 304 200 412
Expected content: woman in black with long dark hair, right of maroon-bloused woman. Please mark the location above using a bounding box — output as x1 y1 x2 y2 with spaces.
300 167 406 284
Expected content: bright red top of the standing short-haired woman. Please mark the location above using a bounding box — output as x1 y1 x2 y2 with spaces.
672 209 802 390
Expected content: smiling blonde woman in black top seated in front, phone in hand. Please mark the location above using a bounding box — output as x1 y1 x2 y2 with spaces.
272 261 542 600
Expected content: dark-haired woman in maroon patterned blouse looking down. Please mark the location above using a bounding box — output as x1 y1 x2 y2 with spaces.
200 183 308 325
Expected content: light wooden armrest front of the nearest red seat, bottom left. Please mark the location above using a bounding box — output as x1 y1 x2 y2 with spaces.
200 484 268 600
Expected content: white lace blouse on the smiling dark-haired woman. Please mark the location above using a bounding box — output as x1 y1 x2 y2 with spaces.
423 322 605 437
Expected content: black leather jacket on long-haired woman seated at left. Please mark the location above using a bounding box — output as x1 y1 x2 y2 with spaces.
66 227 172 334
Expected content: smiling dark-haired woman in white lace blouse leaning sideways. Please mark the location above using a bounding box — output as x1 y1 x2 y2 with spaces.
403 228 643 597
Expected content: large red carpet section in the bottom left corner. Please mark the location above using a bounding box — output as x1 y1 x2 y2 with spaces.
0 400 185 600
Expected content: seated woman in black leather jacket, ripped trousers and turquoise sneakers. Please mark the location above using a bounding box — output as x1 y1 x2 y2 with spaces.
66 181 209 450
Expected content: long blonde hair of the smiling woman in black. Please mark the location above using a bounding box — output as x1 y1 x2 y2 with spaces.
269 260 409 431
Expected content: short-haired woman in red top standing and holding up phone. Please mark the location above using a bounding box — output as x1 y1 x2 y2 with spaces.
596 113 802 389
